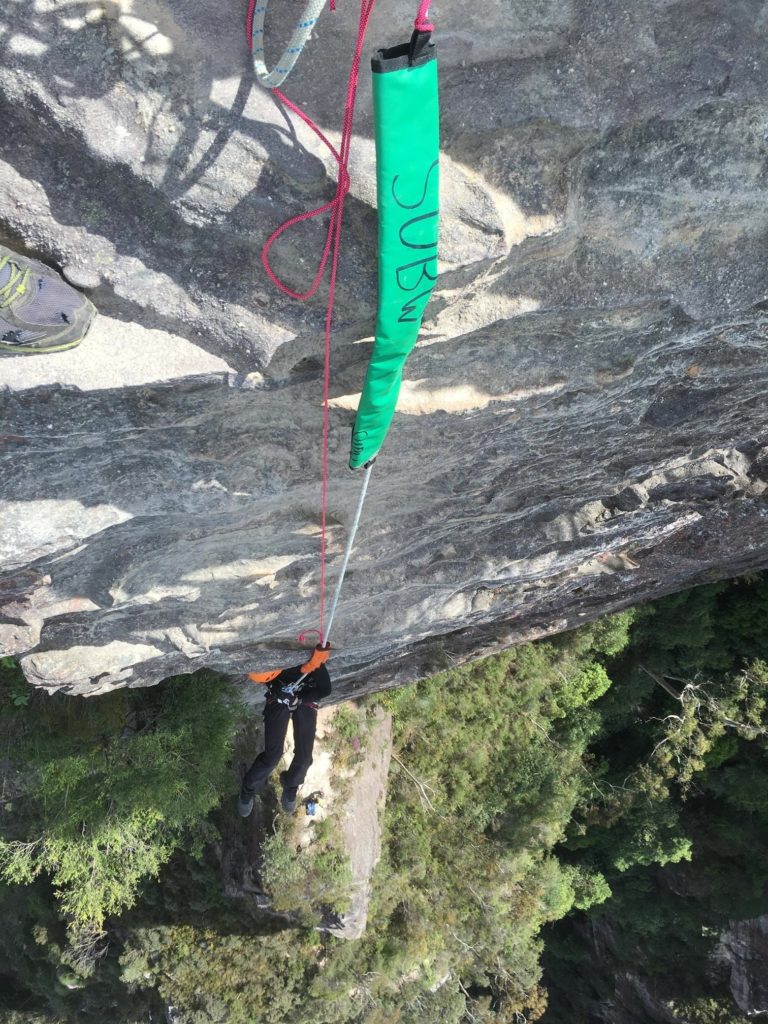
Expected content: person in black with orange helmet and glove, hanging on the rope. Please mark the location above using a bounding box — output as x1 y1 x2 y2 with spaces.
238 643 331 818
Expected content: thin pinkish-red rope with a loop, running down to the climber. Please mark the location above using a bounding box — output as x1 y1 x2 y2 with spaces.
252 0 376 636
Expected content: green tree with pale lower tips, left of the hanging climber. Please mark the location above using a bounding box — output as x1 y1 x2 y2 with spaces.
0 674 236 946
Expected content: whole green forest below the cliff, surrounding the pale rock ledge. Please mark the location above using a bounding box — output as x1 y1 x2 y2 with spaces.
0 574 768 1024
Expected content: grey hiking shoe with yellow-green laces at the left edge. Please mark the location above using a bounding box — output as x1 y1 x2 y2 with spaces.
0 246 95 355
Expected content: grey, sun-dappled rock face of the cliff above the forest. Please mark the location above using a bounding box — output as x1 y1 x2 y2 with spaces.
0 0 768 697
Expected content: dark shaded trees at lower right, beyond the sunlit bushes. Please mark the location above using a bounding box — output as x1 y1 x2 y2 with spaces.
545 575 768 1024
